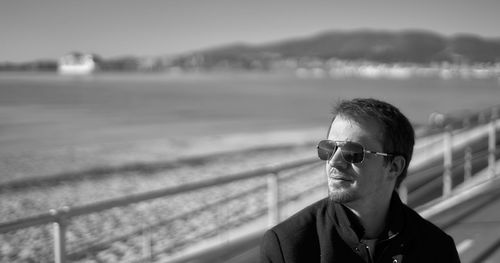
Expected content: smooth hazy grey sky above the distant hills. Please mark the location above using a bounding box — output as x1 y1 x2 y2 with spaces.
0 0 500 62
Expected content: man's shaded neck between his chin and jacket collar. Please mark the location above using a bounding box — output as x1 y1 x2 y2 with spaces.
345 192 391 239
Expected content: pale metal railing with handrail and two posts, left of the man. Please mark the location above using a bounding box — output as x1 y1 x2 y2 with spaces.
0 158 319 263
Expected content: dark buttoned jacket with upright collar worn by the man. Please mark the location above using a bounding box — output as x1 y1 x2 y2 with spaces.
261 193 460 263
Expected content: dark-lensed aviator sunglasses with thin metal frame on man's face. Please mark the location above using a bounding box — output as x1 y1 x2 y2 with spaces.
317 140 392 163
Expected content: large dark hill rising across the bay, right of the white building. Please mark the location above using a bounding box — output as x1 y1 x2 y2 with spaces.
174 30 500 68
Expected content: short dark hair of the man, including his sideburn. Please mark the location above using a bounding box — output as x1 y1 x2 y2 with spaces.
328 98 415 189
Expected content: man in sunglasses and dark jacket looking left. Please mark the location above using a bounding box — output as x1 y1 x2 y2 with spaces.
261 99 460 263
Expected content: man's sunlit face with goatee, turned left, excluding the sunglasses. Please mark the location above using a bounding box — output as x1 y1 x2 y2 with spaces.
326 116 394 206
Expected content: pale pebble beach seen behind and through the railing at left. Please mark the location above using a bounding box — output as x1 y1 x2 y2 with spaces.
0 131 324 262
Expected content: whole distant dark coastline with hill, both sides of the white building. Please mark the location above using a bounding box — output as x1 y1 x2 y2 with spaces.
0 30 500 72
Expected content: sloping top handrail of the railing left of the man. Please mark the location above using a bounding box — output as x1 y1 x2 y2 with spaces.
0 157 319 233
